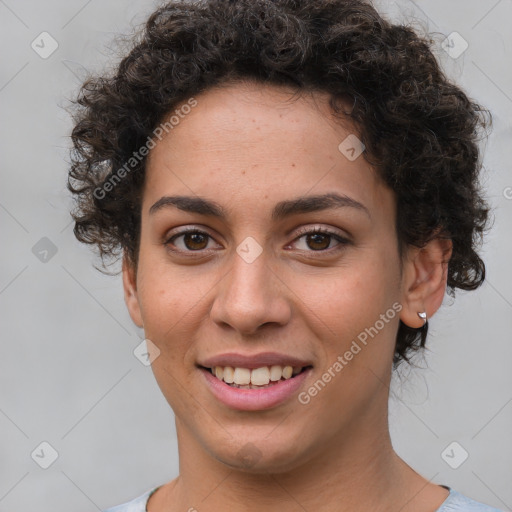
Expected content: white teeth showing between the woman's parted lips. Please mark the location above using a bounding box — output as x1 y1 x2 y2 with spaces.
199 364 312 389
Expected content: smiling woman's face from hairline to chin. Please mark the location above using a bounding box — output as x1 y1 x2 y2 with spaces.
124 83 412 471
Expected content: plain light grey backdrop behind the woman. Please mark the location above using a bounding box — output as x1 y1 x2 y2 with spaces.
0 0 512 512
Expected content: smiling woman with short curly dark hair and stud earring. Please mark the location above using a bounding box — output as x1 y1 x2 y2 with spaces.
69 0 496 512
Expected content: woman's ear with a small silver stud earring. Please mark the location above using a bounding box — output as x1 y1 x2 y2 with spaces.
400 238 453 328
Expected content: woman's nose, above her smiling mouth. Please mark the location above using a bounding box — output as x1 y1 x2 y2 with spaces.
210 245 291 335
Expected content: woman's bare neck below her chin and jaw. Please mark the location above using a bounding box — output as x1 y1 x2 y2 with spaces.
152 400 440 512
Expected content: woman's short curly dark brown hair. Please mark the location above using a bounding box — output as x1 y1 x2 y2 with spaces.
68 0 491 366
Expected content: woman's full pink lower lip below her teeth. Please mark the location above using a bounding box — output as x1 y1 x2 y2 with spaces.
200 368 311 411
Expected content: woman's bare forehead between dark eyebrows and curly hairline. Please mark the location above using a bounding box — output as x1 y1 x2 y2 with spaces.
143 82 389 220
